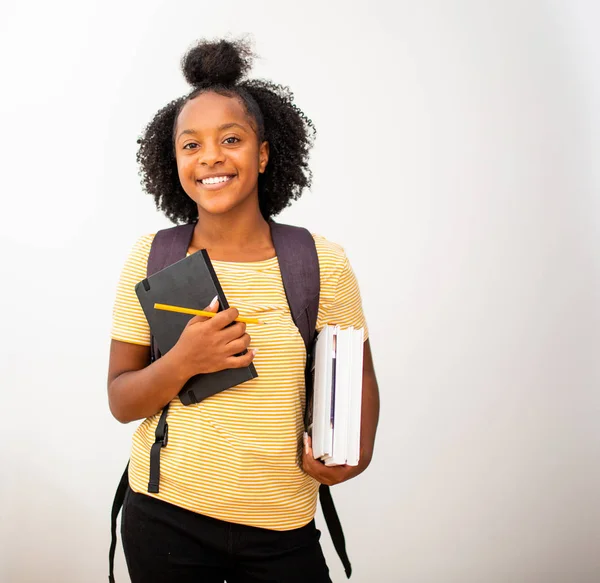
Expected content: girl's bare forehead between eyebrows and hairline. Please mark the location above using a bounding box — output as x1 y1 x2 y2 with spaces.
177 92 250 132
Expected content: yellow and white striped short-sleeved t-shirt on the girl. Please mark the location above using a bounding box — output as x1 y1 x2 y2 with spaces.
111 235 367 530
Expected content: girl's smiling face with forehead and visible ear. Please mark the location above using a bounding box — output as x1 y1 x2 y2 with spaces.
175 92 269 219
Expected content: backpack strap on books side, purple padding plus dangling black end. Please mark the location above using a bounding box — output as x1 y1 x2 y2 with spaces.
270 221 352 578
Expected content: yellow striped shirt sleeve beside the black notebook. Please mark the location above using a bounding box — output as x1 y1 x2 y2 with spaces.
111 235 154 346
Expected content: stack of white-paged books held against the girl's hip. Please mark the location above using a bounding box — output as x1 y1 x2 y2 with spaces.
306 326 364 466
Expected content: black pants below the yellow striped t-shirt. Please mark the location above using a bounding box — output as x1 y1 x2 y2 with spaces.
121 489 331 583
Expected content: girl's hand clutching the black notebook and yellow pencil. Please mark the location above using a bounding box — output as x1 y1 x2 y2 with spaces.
173 298 255 378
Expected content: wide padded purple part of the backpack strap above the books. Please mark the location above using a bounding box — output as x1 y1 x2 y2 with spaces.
269 221 321 353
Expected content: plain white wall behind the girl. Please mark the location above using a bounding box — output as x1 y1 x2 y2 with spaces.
0 0 600 583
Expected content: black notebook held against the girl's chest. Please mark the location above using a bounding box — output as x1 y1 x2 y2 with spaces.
135 249 258 405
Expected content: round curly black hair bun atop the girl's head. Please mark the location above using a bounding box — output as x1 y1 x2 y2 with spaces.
181 40 253 87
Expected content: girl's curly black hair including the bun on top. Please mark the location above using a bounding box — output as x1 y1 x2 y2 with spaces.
137 40 316 224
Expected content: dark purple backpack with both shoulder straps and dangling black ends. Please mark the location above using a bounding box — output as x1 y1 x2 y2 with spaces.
108 221 352 583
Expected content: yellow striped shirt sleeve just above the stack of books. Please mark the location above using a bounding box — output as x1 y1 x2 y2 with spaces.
317 243 369 341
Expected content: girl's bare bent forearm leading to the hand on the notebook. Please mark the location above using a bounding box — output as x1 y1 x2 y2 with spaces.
108 348 189 423
